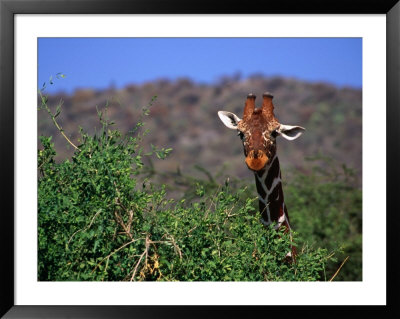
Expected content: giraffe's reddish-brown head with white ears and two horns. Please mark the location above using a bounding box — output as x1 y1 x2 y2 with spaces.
218 92 305 171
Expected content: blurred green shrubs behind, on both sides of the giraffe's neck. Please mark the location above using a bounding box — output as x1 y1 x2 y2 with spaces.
151 159 362 281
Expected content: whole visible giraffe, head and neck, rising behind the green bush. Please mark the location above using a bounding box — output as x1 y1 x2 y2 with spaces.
218 92 305 261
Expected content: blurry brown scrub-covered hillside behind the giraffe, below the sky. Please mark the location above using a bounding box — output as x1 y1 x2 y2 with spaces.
38 75 362 186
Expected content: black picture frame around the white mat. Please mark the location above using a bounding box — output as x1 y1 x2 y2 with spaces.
0 0 400 318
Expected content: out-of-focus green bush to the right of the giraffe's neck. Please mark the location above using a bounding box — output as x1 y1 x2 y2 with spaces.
284 156 362 281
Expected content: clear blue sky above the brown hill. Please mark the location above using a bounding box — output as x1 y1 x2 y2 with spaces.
38 38 362 93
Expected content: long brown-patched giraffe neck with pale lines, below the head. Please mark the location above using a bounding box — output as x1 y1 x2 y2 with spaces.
254 155 290 231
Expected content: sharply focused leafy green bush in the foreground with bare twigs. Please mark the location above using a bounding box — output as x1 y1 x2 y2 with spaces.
38 98 335 281
